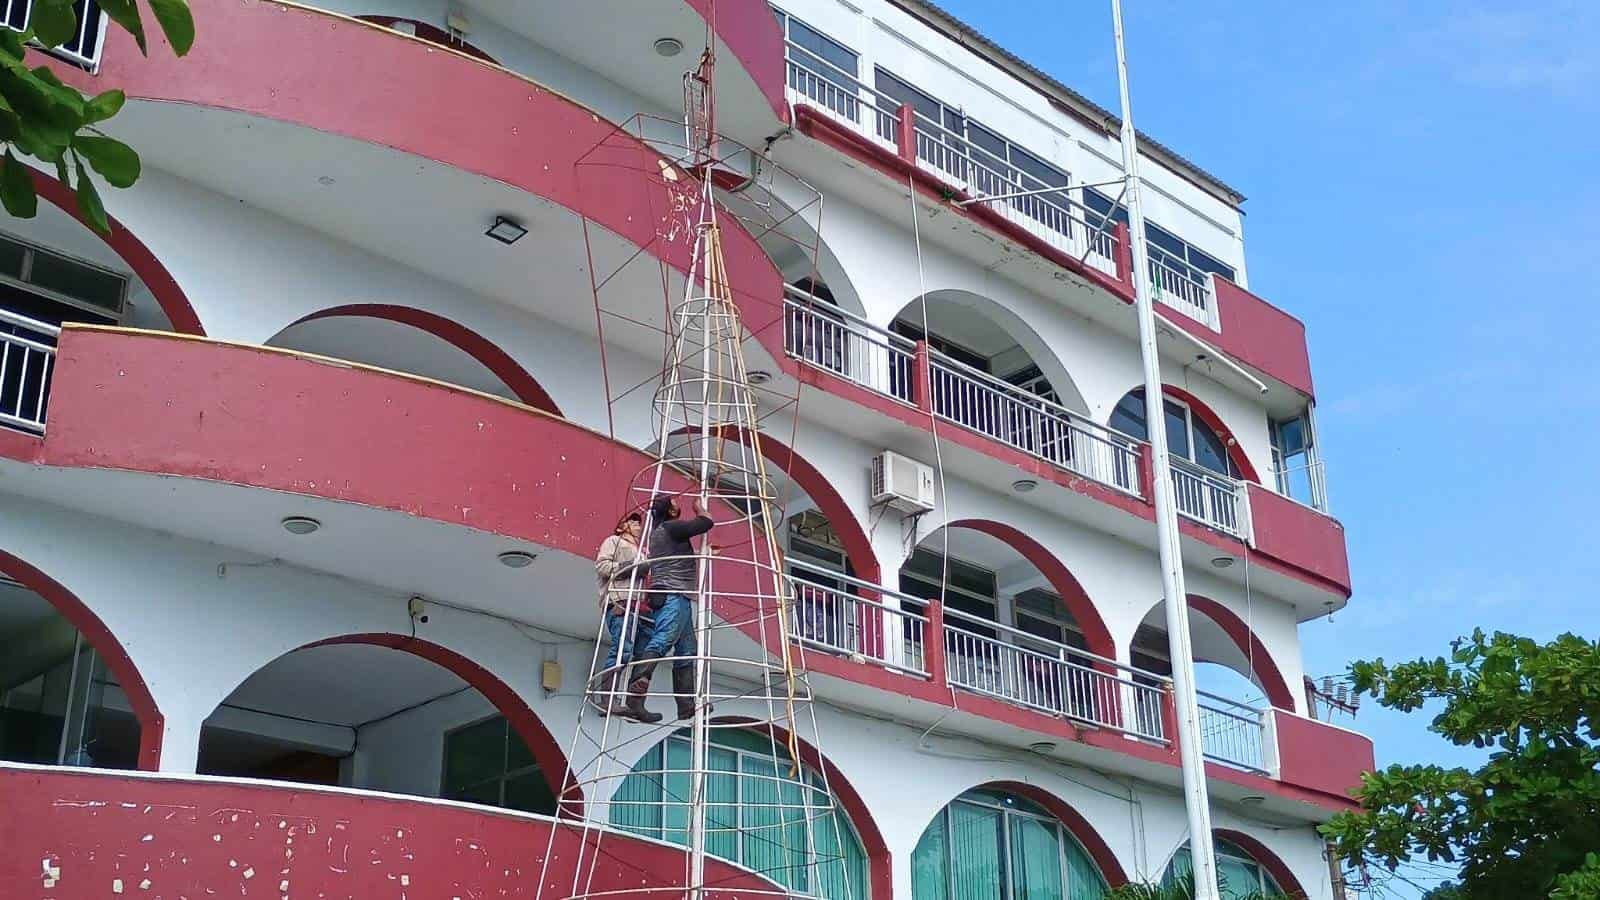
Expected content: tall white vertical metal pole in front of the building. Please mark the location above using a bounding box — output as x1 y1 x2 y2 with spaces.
1110 0 1219 900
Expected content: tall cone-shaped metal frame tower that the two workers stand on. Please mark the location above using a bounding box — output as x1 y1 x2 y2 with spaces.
541 21 864 898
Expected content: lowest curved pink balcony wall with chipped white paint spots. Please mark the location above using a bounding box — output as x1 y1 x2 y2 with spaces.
0 767 776 900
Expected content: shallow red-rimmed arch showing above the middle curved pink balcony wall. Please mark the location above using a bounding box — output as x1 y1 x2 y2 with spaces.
267 303 562 415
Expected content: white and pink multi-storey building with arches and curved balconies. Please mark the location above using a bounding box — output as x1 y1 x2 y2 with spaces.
0 0 1373 900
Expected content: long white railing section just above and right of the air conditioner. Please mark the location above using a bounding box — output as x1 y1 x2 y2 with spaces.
928 351 1139 496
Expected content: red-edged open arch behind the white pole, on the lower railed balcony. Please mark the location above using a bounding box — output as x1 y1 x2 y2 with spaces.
1131 594 1294 772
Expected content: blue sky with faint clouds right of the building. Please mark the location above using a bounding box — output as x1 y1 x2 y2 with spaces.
941 0 1600 897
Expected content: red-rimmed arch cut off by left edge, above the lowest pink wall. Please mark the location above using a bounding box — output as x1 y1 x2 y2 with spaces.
0 551 163 769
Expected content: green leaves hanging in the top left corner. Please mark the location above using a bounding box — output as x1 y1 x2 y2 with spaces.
0 0 195 232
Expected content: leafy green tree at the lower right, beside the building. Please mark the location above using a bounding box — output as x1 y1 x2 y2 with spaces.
1323 631 1600 900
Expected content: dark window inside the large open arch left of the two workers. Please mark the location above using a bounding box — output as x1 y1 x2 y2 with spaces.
438 716 555 815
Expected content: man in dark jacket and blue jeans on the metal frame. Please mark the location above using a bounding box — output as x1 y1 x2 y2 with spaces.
622 496 714 721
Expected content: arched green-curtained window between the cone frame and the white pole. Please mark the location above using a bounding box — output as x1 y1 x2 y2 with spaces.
910 790 1107 900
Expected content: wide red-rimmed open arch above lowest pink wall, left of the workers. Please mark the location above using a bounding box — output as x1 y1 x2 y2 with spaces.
197 634 576 815
